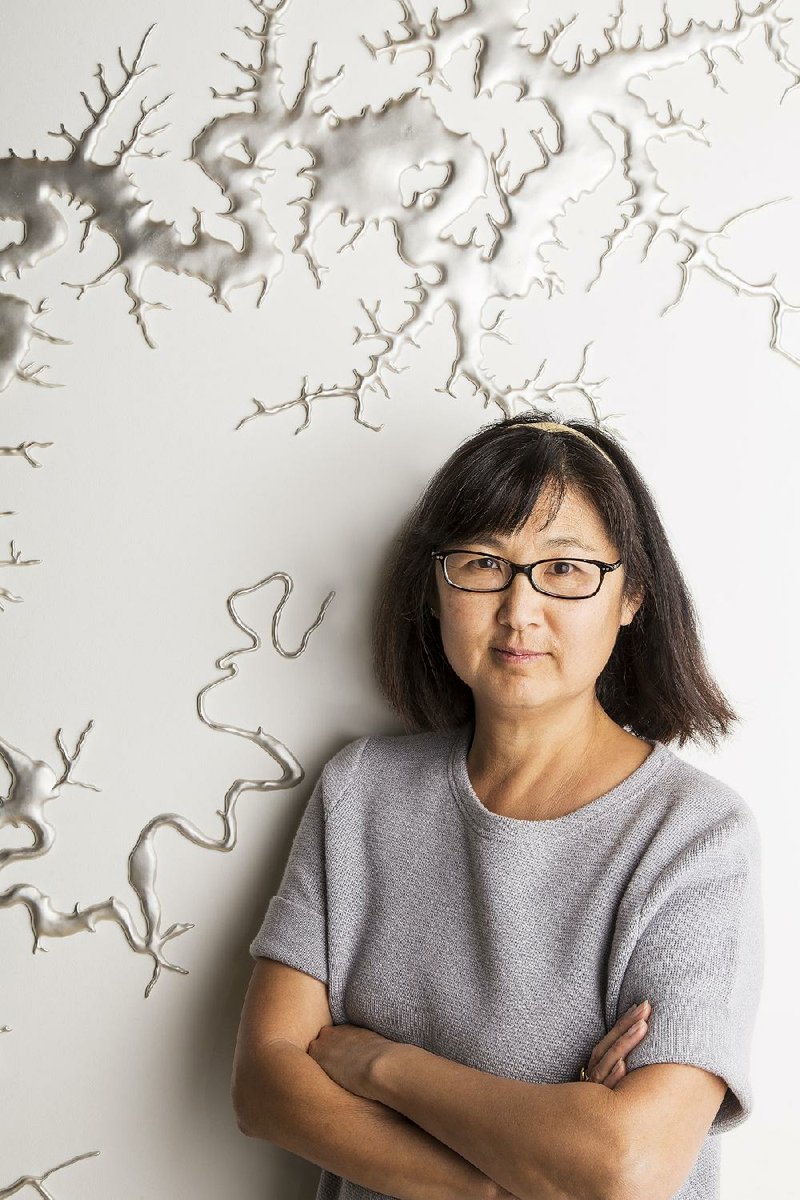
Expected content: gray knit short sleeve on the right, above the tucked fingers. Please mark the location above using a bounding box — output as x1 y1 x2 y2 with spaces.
618 798 764 1135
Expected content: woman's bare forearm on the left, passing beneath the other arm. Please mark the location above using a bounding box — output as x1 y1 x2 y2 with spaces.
237 1042 505 1200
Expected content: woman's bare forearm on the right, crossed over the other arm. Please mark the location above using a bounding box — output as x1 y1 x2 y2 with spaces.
350 1026 727 1200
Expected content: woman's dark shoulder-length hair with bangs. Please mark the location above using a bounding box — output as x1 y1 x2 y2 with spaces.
372 409 739 746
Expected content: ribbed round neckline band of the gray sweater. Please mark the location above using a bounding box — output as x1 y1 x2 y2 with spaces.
447 721 673 840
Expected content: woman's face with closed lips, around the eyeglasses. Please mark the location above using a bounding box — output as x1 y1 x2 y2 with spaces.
434 490 640 712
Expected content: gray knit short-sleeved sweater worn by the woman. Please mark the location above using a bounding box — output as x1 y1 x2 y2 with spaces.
249 724 763 1200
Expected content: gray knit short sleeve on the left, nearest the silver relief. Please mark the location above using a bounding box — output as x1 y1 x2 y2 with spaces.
249 738 367 983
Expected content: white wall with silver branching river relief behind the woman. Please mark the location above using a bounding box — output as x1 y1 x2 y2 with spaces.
0 0 800 1200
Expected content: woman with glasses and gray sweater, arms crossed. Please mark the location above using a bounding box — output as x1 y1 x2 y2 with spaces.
234 413 763 1200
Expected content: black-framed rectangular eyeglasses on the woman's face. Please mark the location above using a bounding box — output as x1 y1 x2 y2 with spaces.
431 550 622 600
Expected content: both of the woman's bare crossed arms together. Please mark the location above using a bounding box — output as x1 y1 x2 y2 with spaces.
234 964 726 1200
